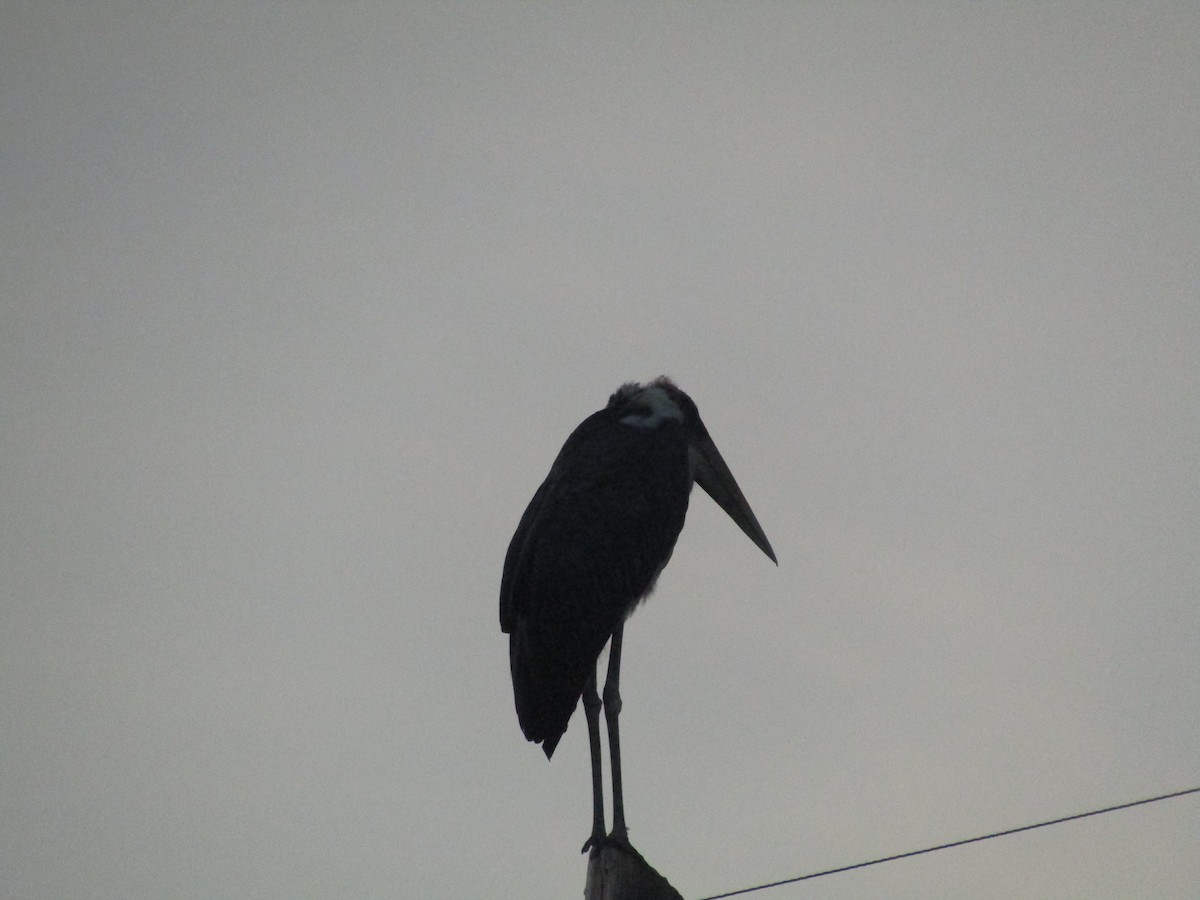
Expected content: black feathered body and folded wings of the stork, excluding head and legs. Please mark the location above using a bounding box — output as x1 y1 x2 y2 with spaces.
500 410 691 756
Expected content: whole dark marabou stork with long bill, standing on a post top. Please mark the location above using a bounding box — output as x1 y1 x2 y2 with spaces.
500 377 775 851
